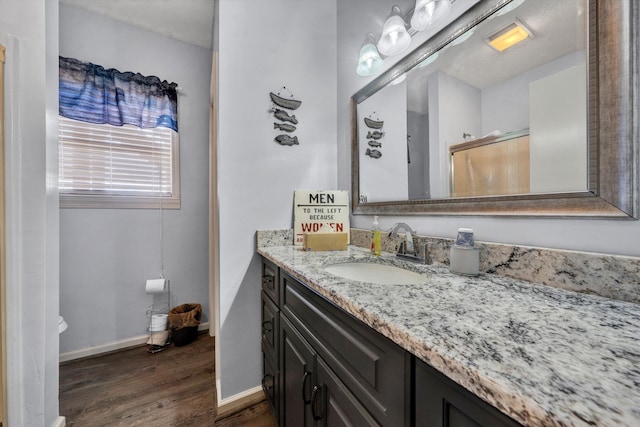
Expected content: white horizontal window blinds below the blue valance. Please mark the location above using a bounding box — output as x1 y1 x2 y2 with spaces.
58 116 180 209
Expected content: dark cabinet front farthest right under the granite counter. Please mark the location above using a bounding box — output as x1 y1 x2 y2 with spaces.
415 360 520 427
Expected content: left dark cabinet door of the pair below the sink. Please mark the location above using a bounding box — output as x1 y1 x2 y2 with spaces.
280 316 316 427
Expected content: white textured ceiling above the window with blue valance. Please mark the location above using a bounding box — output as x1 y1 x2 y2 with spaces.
60 0 213 49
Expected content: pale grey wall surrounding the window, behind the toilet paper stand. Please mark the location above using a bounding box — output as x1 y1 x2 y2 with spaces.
60 4 211 353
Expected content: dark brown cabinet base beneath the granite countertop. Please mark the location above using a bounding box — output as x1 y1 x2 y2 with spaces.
262 260 519 427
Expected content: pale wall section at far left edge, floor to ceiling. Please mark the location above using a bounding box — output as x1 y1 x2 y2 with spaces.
0 0 59 426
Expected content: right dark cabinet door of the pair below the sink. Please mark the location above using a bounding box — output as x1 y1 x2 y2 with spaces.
311 358 380 427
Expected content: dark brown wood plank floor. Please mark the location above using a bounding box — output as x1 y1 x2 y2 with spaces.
60 333 276 427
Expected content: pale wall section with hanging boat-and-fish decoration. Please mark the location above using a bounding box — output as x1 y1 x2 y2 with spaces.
216 0 340 400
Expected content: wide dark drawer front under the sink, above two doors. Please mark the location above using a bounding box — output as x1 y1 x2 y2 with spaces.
281 272 411 426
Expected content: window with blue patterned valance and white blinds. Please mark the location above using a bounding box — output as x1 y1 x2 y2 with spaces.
58 56 180 209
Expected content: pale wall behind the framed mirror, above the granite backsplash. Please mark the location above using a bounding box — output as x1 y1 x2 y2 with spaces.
337 0 640 256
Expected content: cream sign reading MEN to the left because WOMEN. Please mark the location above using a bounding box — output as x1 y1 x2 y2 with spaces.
293 190 349 246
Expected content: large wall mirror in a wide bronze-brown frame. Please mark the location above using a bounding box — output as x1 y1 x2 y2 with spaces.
352 0 640 218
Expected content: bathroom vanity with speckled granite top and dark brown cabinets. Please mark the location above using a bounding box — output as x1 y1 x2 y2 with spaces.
258 245 640 426
